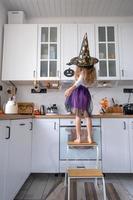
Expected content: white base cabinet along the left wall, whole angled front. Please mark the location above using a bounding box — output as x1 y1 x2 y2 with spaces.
0 119 32 200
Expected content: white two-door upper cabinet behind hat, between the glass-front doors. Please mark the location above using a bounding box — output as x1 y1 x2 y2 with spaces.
61 24 95 80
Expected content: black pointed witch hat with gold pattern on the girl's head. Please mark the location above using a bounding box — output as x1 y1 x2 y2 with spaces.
67 33 98 69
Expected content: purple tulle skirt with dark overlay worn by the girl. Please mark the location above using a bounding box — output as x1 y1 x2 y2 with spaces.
65 85 92 117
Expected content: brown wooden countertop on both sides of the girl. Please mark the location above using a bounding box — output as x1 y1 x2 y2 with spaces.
0 113 133 120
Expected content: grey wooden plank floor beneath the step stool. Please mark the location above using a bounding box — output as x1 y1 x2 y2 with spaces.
15 174 133 200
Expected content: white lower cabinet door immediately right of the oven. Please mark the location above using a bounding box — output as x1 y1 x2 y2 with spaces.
102 119 130 173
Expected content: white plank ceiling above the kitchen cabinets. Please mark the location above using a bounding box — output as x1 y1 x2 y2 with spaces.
0 0 133 18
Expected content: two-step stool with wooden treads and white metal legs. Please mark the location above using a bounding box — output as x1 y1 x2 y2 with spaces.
67 141 106 200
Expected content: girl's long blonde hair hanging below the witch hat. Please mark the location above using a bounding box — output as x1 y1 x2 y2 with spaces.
75 66 96 84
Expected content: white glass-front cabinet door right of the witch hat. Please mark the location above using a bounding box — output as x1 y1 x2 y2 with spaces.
96 25 119 80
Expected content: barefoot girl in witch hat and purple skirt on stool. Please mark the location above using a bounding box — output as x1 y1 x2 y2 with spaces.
65 34 98 144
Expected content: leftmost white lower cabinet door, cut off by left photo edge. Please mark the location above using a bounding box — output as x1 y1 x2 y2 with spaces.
0 120 10 200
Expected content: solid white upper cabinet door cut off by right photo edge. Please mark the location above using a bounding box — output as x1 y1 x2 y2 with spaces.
119 23 133 80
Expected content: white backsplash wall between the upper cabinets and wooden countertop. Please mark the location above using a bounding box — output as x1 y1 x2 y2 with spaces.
16 85 133 114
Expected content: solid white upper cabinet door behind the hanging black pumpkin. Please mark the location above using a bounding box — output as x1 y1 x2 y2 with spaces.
61 24 78 80
